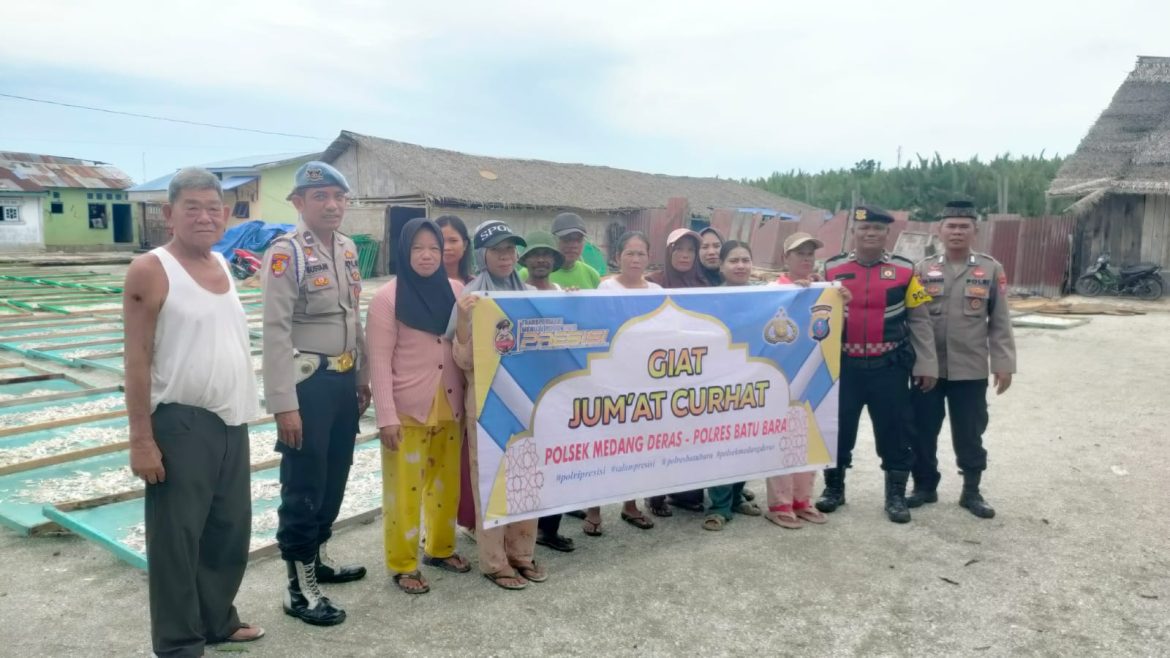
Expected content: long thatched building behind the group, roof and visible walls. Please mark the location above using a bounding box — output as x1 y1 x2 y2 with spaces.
322 131 824 272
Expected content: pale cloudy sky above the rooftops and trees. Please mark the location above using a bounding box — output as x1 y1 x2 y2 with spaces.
0 0 1170 181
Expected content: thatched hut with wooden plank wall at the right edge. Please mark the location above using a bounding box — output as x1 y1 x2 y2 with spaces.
1048 56 1170 266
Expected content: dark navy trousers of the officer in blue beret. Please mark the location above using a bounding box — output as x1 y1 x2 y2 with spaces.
276 357 358 562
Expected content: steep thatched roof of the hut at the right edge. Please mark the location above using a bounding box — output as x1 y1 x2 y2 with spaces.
1048 57 1170 197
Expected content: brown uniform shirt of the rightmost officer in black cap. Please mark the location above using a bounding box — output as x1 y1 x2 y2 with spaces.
915 252 1016 381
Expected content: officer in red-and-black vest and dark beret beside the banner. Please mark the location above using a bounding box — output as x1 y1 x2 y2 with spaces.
817 206 938 523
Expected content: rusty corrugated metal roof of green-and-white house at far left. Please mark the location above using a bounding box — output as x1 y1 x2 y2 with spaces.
0 152 133 192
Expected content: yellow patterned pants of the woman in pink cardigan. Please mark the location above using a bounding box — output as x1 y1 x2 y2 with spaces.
381 423 461 574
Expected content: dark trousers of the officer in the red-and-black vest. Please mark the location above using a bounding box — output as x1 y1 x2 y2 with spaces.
837 347 914 471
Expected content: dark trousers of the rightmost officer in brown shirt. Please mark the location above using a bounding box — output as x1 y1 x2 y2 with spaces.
913 379 987 491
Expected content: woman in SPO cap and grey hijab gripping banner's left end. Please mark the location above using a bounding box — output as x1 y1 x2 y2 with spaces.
447 220 549 589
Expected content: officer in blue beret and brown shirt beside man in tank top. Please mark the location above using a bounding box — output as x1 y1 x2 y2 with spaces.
262 162 370 625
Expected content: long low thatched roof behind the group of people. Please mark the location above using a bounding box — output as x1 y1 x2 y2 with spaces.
322 131 819 215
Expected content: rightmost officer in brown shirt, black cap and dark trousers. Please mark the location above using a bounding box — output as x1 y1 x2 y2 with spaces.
907 201 1016 519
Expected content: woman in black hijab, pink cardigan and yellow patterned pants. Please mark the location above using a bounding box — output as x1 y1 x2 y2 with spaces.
366 218 472 594
